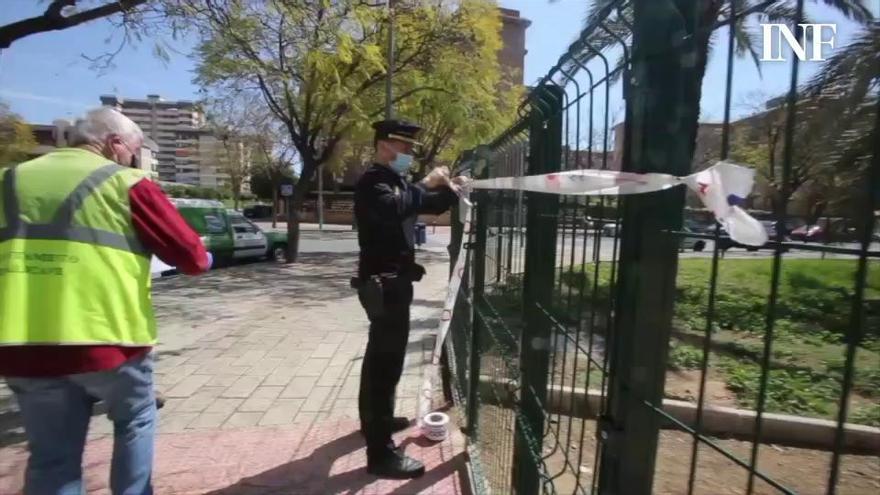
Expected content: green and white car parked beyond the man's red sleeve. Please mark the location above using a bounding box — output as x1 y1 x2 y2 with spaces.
171 199 287 263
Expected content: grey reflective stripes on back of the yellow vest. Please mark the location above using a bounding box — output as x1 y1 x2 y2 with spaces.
0 164 149 256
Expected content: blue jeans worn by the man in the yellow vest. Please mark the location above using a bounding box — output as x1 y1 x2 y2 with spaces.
6 354 156 495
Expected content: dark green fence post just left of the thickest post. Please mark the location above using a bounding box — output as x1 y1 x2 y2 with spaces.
513 86 563 495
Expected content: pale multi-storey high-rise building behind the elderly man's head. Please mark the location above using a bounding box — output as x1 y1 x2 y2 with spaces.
101 95 228 188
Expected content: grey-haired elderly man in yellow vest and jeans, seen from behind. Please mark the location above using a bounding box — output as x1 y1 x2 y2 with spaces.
0 108 211 495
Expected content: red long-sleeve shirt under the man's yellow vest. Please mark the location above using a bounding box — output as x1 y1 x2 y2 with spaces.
0 179 210 377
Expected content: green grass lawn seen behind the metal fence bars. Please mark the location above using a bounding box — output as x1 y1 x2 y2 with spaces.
556 259 880 426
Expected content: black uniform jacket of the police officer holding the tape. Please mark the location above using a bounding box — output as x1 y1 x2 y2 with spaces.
354 164 458 280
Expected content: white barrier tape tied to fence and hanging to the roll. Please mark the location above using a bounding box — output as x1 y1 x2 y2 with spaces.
419 161 768 418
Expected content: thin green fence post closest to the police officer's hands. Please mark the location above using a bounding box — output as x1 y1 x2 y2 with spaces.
466 151 489 442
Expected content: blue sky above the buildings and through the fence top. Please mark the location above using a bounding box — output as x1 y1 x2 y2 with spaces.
0 0 880 128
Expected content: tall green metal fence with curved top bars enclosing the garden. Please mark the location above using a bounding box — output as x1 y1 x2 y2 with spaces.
446 0 880 494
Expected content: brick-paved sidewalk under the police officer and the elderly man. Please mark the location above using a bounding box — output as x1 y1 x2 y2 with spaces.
0 252 467 495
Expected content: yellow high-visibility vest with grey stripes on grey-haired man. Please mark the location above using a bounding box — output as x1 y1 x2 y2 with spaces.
0 148 156 346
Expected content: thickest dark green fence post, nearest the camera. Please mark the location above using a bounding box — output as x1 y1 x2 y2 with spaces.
598 0 705 495
